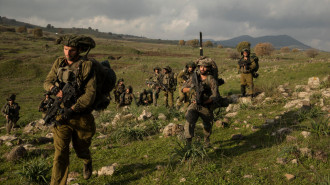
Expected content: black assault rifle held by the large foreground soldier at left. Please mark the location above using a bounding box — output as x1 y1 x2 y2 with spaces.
44 82 77 125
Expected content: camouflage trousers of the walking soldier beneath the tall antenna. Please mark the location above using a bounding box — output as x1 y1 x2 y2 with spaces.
184 103 213 139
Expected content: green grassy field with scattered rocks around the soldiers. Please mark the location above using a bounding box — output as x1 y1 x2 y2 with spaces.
0 32 330 184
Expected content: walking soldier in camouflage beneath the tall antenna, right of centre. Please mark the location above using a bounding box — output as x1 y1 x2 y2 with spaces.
182 58 220 147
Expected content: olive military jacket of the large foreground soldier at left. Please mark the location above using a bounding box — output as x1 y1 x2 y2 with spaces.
44 57 96 112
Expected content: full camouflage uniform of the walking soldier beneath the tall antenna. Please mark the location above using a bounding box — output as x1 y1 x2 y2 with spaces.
183 60 220 143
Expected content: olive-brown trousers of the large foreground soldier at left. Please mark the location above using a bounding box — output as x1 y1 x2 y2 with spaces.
50 114 95 185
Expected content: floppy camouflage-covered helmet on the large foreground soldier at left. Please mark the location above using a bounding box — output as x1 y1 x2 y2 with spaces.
55 34 96 55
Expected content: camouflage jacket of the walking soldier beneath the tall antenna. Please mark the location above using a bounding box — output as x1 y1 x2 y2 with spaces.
183 75 220 104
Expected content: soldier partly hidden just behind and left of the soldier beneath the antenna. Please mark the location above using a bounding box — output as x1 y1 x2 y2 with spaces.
176 62 196 110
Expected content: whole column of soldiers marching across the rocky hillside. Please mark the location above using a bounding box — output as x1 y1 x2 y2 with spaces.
1 35 257 184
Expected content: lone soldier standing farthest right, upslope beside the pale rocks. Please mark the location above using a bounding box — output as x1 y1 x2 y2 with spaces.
238 48 256 97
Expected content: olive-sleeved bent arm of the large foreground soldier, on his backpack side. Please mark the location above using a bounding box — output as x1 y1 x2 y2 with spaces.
72 61 96 112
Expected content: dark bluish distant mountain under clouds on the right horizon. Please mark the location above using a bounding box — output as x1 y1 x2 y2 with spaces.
215 35 311 50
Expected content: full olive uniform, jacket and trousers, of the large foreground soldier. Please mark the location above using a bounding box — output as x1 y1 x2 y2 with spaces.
44 35 96 184
